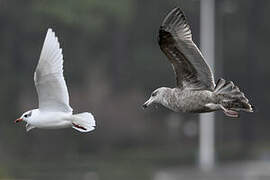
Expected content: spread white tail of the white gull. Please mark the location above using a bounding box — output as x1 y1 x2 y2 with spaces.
72 112 96 132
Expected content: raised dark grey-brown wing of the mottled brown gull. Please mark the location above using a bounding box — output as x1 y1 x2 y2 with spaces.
159 8 215 90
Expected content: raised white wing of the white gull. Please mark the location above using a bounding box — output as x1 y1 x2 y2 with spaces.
34 29 72 112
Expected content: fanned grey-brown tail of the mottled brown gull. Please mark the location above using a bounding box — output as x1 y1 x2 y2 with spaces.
214 79 253 116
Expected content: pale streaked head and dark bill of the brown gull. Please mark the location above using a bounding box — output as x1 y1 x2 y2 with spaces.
142 87 170 109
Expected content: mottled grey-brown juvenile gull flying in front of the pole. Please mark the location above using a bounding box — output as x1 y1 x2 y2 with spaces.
143 8 253 117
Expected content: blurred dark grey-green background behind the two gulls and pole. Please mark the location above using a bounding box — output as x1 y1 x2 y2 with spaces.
0 0 270 180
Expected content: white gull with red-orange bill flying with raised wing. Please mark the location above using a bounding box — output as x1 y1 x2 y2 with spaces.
15 29 95 132
